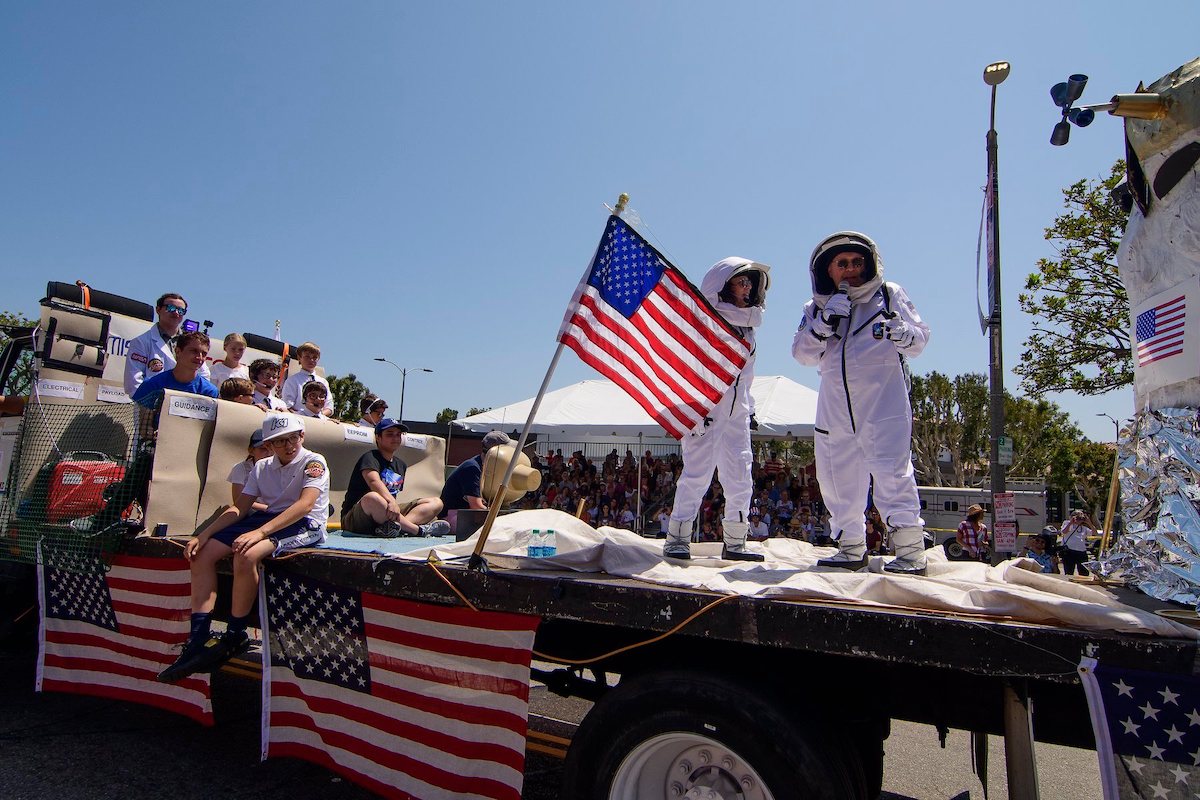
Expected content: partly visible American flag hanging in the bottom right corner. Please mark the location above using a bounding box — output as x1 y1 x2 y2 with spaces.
1079 658 1200 800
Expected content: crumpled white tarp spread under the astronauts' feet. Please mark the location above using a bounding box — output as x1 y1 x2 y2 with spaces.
388 509 1200 638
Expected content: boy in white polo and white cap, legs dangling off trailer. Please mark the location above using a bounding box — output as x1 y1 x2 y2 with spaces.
158 414 329 682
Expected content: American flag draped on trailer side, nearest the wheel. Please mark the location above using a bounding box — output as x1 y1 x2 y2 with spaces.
267 564 539 800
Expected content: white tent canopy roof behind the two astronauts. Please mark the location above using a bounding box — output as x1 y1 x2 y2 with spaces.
454 375 817 439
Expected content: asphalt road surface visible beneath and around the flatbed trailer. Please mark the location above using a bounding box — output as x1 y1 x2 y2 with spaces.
0 636 1099 800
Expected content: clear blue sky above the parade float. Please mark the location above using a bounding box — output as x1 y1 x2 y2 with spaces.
0 0 1200 440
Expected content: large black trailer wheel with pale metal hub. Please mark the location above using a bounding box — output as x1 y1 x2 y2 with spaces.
562 672 866 800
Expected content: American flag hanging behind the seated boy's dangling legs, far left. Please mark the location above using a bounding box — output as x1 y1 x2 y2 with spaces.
37 551 212 724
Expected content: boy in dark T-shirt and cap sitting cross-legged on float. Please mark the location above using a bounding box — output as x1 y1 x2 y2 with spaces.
342 417 450 539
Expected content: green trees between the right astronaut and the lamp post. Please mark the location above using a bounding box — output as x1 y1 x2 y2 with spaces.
911 371 989 486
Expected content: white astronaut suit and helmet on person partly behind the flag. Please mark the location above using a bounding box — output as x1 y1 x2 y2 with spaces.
662 257 770 561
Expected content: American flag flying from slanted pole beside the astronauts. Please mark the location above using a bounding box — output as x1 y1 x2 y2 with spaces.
558 216 750 439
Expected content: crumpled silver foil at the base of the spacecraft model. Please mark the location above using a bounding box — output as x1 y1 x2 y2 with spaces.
1088 408 1200 607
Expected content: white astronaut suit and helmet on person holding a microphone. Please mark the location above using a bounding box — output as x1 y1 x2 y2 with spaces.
792 230 929 575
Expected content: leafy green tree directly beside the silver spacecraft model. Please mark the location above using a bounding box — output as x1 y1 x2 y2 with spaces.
1015 161 1133 397
